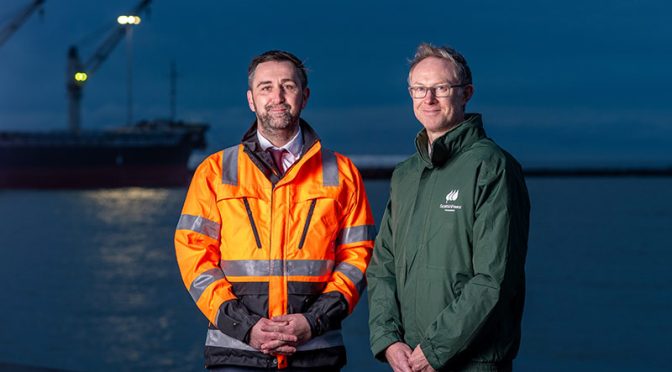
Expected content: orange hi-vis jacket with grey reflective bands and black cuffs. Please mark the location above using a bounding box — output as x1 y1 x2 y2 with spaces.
175 120 375 369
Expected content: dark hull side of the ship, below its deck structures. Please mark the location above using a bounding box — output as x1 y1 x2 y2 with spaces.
0 145 191 189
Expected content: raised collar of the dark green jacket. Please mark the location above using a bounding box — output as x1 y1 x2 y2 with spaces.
415 114 485 168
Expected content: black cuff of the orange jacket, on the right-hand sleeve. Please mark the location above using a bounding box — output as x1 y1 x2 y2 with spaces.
303 292 348 337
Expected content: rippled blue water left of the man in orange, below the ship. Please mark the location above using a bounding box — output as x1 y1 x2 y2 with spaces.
0 188 205 370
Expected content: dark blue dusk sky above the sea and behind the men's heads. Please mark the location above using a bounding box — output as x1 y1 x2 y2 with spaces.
0 0 672 166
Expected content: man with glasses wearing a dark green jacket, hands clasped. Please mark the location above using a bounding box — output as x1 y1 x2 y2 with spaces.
366 44 530 371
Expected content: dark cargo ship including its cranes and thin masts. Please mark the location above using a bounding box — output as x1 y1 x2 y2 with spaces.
0 0 214 189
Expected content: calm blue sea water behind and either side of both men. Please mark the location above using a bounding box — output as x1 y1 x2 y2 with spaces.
0 178 672 371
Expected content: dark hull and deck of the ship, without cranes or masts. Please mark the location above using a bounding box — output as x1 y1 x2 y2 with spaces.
0 120 208 189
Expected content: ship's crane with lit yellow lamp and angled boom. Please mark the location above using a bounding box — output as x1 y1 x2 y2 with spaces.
66 0 151 134
